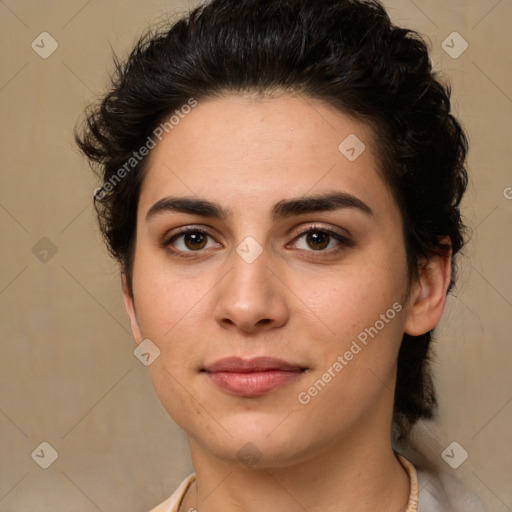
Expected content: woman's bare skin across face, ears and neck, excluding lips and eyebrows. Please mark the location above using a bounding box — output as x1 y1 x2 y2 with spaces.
123 94 450 512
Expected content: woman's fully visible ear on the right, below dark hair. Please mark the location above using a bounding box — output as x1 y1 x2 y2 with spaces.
404 237 452 336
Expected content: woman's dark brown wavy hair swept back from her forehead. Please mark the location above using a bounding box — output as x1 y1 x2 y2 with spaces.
76 0 467 439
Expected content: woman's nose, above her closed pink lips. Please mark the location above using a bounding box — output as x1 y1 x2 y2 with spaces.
213 245 289 334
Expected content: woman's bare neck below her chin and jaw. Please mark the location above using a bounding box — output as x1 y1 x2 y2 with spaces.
180 428 410 512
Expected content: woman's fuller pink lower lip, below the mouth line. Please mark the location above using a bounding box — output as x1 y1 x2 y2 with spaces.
208 370 303 397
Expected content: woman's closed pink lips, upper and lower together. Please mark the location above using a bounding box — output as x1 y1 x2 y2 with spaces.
204 357 307 397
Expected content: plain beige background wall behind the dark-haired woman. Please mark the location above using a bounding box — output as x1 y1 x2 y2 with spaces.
0 0 512 512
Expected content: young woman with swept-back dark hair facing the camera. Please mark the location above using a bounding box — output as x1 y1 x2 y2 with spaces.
77 0 484 512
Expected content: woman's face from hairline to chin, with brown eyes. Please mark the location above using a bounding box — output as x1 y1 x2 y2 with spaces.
125 95 424 466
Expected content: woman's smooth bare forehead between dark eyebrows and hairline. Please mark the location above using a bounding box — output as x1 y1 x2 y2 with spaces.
139 95 398 220
